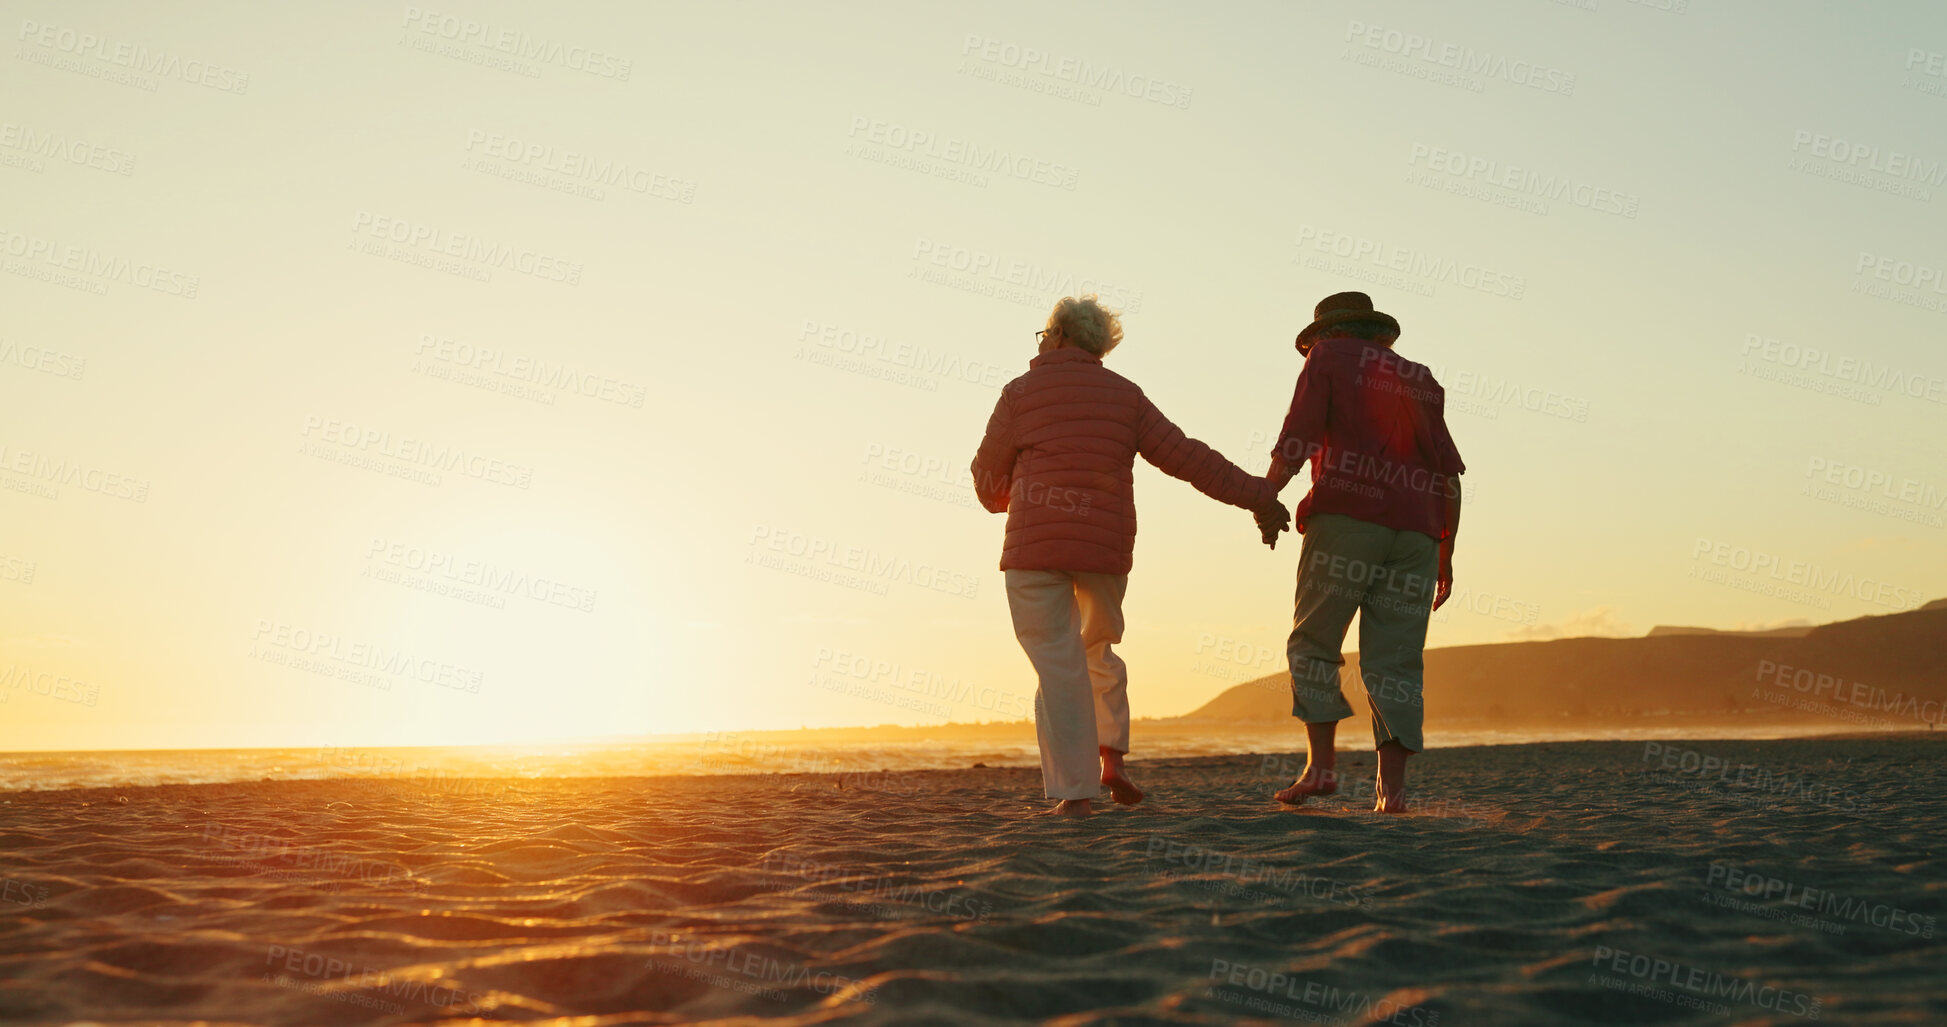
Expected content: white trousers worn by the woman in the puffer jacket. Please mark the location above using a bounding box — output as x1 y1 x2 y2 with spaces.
1007 571 1129 799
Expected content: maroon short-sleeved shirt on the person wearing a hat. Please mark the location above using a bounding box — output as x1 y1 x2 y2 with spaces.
1275 337 1466 540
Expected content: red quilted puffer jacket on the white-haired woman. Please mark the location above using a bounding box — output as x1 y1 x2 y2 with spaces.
974 349 1277 575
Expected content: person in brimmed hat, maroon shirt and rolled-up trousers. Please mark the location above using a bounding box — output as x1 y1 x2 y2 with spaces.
1258 292 1466 813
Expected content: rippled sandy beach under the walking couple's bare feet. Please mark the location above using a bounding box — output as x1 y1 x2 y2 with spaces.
0 739 1947 1025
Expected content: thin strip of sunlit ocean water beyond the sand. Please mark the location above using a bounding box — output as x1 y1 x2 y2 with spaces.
0 723 1861 791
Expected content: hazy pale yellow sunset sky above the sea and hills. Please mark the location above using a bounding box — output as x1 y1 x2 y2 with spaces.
0 0 1947 748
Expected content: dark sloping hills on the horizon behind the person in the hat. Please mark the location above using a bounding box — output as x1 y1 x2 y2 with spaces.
1170 600 1947 731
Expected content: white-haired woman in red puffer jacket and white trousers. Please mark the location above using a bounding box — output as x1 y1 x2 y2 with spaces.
974 296 1289 817
